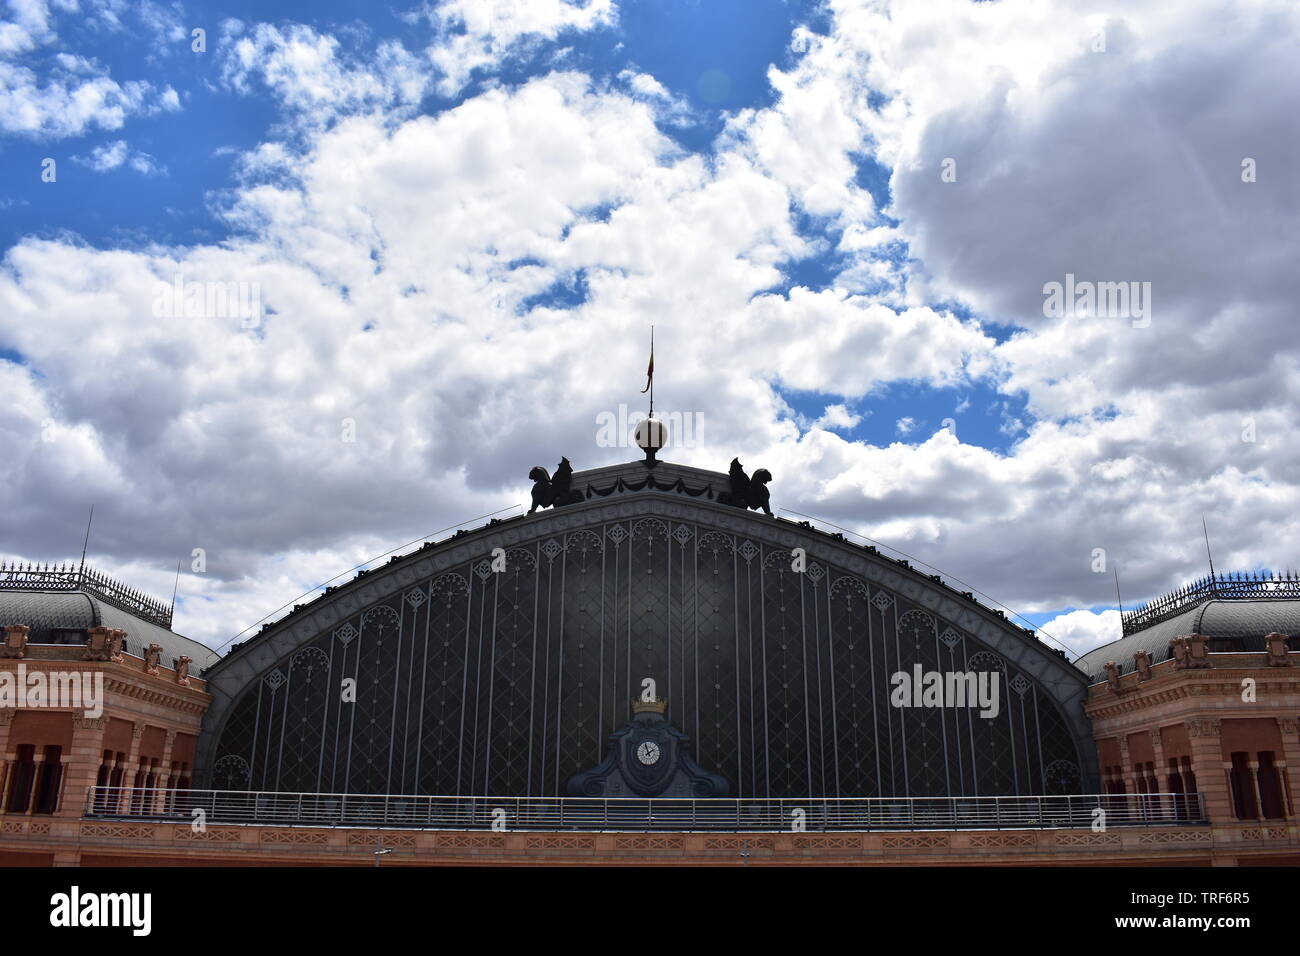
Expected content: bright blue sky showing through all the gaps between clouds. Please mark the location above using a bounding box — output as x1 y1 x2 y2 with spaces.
0 0 993 453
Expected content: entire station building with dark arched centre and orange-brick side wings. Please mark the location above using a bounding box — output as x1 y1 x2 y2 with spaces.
0 455 1300 865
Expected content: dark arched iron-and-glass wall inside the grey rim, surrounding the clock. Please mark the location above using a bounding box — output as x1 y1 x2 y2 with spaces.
213 516 1084 799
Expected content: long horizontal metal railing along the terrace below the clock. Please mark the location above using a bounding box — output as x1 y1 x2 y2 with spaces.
86 787 1205 831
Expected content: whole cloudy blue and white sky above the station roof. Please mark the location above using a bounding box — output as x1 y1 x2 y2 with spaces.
0 0 1300 656
